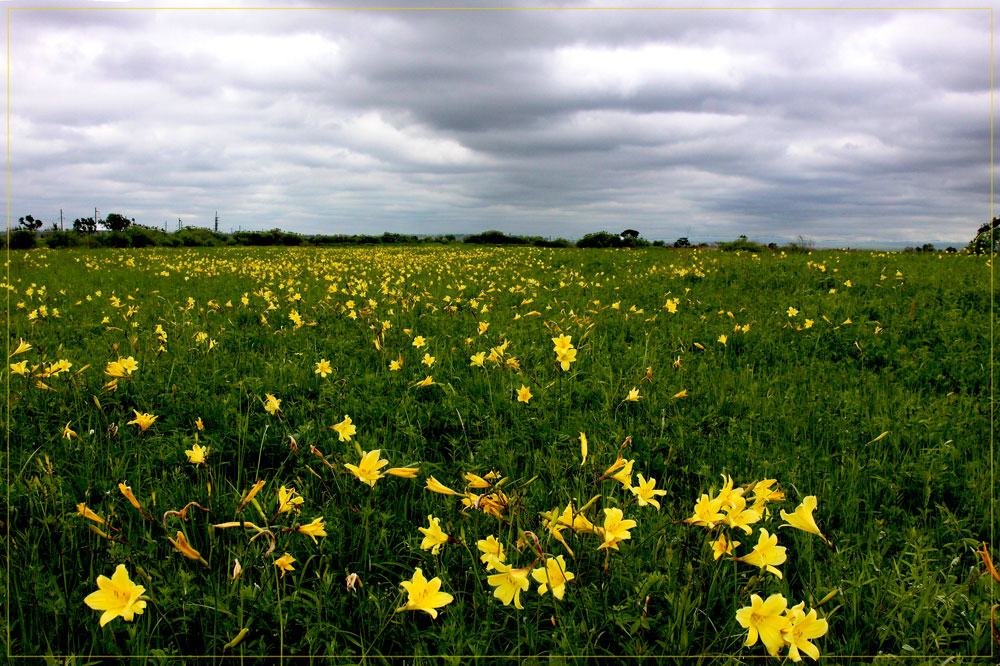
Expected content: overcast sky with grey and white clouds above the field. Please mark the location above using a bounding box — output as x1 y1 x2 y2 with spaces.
0 1 990 242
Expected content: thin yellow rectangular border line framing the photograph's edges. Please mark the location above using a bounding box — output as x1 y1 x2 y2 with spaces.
4 6 996 661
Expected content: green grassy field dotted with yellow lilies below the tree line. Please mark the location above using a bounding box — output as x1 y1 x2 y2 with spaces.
4 247 1000 664
